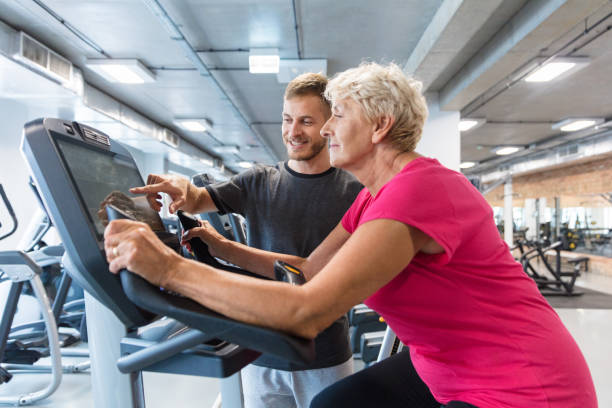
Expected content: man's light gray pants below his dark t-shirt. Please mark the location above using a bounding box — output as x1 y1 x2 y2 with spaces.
241 358 353 408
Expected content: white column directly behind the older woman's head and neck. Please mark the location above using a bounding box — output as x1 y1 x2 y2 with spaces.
416 93 461 171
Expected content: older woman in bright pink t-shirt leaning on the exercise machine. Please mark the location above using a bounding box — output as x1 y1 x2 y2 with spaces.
105 63 597 408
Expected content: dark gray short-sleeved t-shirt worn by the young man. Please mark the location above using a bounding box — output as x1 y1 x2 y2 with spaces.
206 162 363 371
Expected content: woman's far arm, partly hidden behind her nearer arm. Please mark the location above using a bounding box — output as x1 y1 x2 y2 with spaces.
183 222 350 280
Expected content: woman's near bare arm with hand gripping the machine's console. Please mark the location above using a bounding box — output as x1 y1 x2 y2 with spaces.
105 219 431 338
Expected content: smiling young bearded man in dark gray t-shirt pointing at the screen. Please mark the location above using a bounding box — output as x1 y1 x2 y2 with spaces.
132 74 362 408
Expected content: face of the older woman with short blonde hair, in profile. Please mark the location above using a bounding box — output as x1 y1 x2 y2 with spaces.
321 98 374 168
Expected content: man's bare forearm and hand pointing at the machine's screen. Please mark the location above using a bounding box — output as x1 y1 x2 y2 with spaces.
130 174 218 214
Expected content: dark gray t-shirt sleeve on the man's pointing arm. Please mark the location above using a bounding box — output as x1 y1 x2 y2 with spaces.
206 170 256 215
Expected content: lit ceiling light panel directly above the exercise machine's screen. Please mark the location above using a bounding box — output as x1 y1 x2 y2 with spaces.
85 59 155 84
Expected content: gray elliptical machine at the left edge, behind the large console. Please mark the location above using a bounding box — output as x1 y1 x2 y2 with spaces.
0 180 89 405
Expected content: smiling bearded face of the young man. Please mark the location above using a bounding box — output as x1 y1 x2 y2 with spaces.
282 95 329 161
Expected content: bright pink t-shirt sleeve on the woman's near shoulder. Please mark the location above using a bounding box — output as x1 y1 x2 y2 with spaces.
359 175 461 264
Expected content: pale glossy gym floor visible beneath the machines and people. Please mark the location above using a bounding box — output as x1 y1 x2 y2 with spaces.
0 273 612 408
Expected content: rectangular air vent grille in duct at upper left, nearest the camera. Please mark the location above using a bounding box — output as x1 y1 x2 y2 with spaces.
15 32 72 82
